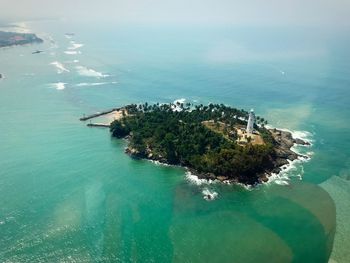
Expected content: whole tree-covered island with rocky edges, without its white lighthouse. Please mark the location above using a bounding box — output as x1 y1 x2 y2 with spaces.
81 102 310 186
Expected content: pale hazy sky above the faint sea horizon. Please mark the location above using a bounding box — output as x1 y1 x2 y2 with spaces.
0 0 350 27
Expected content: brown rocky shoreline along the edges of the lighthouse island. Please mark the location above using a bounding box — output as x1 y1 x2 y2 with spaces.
125 129 311 187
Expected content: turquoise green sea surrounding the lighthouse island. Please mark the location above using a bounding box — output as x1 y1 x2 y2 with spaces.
0 22 350 262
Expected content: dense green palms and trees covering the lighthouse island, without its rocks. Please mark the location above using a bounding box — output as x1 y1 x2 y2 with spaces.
110 103 274 184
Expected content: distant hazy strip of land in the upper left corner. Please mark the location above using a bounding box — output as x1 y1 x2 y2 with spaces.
0 31 43 48
